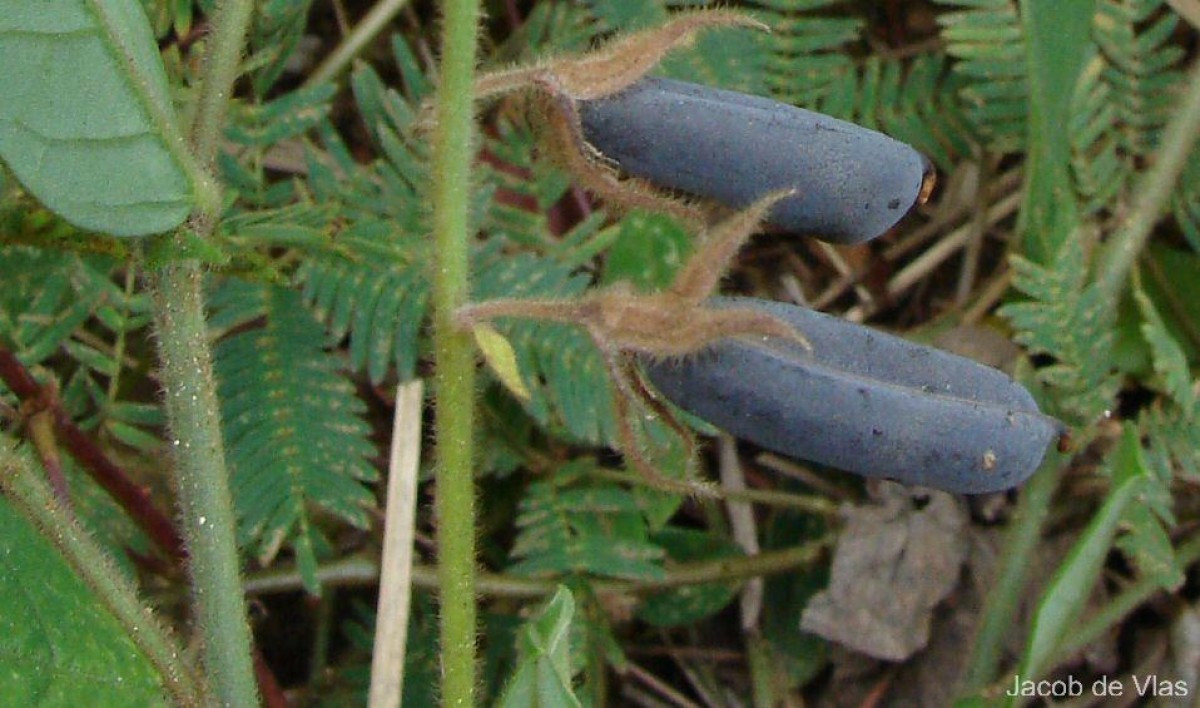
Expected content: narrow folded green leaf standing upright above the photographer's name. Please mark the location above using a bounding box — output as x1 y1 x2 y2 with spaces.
1018 426 1150 696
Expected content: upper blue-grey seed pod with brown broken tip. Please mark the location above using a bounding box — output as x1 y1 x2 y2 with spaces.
578 78 932 244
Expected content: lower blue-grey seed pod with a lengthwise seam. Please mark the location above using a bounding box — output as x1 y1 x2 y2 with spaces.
643 298 1064 494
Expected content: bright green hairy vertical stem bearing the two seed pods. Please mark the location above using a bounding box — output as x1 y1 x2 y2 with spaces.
433 0 479 707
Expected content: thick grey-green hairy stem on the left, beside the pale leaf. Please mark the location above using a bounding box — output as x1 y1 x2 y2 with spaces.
151 0 258 706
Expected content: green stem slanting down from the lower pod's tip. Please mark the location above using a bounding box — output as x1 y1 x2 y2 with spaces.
961 450 1068 694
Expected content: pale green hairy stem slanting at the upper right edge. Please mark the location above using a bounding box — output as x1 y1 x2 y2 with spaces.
1096 54 1200 302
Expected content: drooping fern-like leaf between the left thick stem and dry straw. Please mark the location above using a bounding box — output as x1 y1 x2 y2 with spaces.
212 282 378 593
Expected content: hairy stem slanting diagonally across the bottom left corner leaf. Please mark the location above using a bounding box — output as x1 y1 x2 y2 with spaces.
0 439 204 706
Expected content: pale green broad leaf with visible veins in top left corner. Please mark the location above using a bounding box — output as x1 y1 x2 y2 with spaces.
0 0 215 236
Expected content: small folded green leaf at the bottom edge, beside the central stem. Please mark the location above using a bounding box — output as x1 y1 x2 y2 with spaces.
499 586 582 708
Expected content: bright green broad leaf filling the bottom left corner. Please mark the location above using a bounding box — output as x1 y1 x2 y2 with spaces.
0 497 167 707
